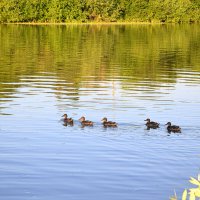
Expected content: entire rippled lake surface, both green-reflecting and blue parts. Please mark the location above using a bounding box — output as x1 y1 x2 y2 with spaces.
0 25 200 200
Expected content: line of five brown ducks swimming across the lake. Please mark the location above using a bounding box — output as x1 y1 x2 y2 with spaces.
62 114 181 133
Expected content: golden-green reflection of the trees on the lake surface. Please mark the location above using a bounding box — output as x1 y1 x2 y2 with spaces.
0 25 200 106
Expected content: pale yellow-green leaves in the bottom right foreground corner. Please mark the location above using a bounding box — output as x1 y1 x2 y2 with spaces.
170 176 200 200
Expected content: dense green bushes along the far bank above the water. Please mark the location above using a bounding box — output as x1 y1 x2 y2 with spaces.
0 0 200 23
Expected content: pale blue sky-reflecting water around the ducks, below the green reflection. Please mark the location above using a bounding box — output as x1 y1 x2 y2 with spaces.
0 76 200 200
